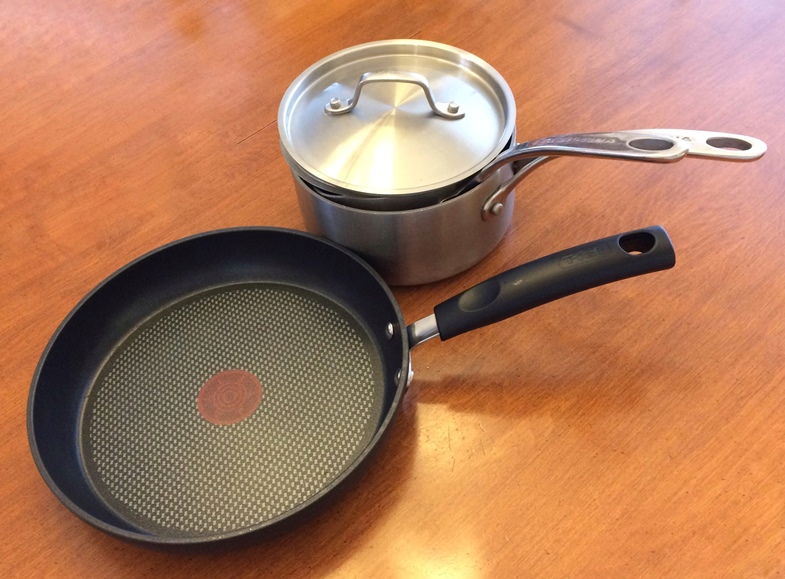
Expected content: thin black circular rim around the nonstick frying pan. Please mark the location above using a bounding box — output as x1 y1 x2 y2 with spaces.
26 226 410 547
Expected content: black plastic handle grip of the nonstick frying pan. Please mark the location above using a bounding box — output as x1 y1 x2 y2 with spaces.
434 225 676 340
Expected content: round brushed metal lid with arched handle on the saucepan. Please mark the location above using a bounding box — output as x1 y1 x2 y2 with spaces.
278 40 515 202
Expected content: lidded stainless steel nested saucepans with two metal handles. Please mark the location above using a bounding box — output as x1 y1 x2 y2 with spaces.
278 40 766 285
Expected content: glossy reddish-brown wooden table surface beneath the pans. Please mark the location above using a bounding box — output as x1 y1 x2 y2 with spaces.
0 0 785 578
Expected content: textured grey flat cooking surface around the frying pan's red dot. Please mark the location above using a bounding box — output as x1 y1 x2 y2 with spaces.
80 283 384 537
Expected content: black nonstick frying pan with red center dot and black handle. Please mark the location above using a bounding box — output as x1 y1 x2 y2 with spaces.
28 227 675 547
